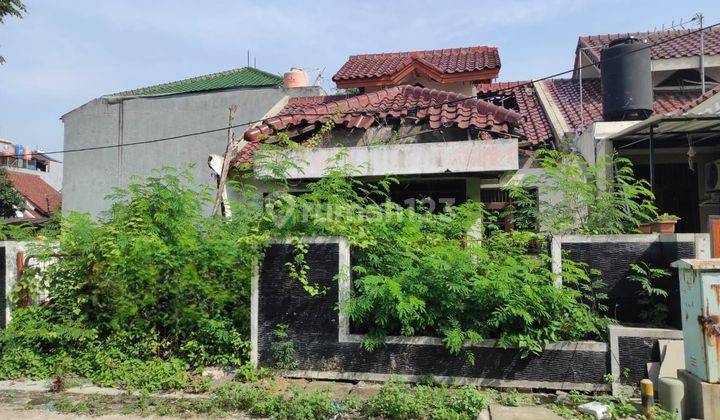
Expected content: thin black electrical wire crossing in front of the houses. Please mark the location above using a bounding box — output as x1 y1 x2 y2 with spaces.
13 18 720 159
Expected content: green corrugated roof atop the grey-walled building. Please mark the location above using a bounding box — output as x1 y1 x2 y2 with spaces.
105 67 283 96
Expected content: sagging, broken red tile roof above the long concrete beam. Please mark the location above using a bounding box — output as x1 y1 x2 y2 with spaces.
234 85 523 163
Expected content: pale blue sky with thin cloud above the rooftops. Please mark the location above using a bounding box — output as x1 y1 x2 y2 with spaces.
0 0 720 156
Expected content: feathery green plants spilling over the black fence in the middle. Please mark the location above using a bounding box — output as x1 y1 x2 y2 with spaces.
246 153 606 354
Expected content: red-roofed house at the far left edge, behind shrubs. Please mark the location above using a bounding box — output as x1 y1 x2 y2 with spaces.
5 171 61 221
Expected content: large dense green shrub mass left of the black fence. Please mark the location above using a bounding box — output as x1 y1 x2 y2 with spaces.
0 169 258 390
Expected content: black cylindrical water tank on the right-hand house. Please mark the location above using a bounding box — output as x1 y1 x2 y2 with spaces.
600 37 653 121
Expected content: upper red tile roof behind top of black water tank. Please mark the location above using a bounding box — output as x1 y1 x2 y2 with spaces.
578 28 720 71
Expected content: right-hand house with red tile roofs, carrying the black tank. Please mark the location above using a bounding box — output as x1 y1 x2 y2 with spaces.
564 28 720 236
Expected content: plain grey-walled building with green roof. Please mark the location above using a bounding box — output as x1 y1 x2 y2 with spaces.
61 67 324 216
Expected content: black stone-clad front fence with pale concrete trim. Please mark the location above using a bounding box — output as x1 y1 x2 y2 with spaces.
251 235 702 391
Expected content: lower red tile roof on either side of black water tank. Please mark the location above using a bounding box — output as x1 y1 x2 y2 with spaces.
540 79 700 130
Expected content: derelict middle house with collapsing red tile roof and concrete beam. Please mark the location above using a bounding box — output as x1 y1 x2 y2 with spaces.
233 46 536 210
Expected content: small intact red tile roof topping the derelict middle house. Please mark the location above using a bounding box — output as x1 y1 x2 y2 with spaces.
333 46 500 87
